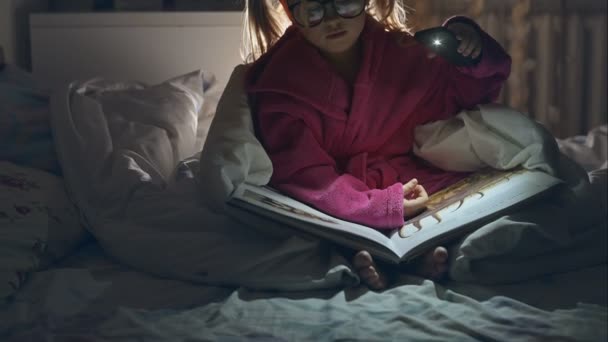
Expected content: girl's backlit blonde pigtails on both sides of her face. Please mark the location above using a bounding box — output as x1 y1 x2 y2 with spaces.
241 0 409 63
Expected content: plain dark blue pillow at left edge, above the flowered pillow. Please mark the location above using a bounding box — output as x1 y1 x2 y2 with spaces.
0 65 61 174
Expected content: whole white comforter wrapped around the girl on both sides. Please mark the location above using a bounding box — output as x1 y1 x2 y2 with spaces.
52 67 606 290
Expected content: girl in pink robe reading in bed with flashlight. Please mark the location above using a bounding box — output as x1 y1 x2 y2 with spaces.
246 0 511 289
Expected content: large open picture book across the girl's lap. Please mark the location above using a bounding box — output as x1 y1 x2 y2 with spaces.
229 169 562 263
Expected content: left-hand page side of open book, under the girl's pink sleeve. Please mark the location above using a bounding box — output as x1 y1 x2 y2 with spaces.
230 184 399 262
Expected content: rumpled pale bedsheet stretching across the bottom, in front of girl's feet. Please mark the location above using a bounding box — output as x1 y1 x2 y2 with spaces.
0 244 608 341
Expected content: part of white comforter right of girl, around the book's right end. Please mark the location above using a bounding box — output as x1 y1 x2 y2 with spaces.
414 104 608 283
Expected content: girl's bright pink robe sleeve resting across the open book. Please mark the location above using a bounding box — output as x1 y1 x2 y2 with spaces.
258 107 404 229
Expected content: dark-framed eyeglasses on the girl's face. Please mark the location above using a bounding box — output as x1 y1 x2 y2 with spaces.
288 0 365 27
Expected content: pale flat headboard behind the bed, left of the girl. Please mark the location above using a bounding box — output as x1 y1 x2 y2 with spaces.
30 12 242 86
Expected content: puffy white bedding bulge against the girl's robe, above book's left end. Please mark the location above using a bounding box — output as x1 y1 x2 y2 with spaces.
199 65 273 212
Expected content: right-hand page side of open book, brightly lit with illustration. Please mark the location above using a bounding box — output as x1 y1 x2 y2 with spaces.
391 169 561 259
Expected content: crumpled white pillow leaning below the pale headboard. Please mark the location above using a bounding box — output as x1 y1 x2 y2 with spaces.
67 70 219 181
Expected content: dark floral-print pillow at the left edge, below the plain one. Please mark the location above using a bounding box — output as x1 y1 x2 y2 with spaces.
0 161 88 298
